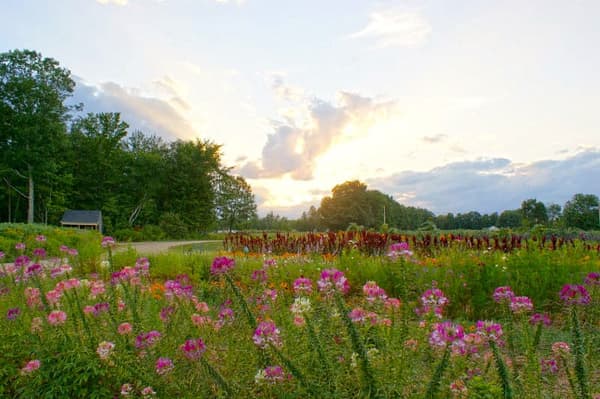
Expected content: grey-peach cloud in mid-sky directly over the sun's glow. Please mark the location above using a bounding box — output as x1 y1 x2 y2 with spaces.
238 92 395 180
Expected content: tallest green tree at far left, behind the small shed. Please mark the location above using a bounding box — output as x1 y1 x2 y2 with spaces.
0 50 75 223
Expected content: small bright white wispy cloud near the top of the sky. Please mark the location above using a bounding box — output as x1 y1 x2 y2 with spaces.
350 9 431 48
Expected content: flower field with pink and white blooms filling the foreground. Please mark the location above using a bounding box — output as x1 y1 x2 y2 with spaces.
0 235 600 399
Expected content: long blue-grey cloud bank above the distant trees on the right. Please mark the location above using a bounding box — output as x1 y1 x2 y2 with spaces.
367 149 600 213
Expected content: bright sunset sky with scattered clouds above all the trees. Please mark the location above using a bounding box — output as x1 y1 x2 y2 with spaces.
0 0 600 218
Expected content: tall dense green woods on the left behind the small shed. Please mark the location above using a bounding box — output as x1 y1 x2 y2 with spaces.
0 50 256 237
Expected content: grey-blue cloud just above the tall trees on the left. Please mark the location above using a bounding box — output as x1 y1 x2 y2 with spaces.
72 78 197 140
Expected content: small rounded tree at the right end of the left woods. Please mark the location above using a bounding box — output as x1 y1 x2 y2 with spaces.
215 174 256 231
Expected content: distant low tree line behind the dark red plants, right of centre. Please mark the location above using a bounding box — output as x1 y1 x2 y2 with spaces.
256 180 600 231
